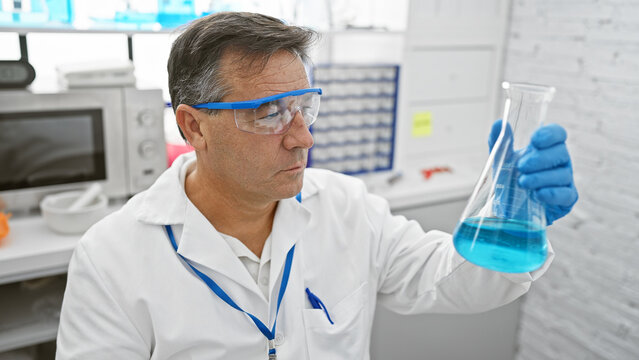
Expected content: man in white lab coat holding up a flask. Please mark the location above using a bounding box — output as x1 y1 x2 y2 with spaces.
58 13 576 360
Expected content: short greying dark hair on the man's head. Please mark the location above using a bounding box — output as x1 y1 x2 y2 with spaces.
167 12 319 137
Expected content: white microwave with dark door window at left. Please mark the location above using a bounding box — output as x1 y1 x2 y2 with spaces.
0 87 167 211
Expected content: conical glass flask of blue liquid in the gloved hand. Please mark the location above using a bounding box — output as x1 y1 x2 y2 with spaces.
453 82 555 273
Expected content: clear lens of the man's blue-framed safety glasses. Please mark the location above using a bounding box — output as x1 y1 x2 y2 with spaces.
234 93 320 134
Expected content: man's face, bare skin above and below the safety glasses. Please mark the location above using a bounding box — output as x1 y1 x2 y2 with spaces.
202 51 313 201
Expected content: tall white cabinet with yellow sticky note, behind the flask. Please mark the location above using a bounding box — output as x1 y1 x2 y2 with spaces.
395 0 510 168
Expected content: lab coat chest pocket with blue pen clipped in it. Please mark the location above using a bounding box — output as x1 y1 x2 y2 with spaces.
303 283 368 360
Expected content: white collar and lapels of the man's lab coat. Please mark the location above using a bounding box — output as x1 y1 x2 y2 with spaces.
136 153 320 299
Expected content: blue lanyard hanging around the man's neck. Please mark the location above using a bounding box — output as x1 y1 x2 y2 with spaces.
164 192 302 359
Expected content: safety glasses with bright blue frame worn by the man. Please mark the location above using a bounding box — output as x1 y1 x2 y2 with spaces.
193 88 322 134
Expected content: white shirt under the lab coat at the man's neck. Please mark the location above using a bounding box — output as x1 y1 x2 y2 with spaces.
180 161 271 299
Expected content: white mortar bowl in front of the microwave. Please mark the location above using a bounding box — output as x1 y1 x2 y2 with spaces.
40 191 108 234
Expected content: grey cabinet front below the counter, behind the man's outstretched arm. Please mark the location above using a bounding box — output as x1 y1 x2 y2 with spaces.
371 199 521 360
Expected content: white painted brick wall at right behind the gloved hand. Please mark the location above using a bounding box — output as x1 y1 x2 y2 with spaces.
504 0 639 360
